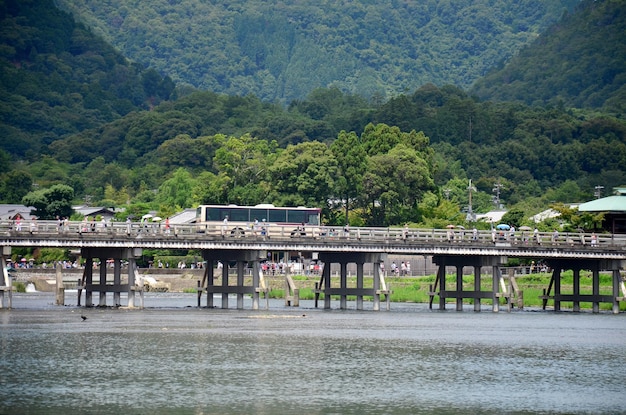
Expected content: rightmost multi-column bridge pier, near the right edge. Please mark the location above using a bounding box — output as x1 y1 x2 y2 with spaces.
540 259 626 314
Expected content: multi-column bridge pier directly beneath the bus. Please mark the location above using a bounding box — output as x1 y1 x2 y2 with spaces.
198 249 269 310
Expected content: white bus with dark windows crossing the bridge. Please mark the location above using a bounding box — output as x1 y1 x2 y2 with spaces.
196 204 322 236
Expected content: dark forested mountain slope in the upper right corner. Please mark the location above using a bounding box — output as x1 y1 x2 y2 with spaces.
471 0 626 114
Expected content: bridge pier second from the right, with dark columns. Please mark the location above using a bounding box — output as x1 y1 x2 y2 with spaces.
428 255 511 312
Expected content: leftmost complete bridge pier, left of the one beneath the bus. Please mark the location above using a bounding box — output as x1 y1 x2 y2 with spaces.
78 248 143 308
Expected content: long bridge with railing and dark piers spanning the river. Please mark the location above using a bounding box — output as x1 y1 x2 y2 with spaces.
0 221 626 313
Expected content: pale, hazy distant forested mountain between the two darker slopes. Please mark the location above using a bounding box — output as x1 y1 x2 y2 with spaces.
56 0 579 104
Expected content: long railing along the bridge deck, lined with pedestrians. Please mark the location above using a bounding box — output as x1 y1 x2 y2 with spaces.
0 220 626 249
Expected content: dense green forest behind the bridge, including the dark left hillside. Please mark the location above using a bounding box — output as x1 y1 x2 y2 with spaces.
0 0 626 231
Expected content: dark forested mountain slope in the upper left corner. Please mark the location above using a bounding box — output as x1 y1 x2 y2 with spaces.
0 0 174 159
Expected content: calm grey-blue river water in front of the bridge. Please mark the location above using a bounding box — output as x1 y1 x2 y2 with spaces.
0 293 626 415
